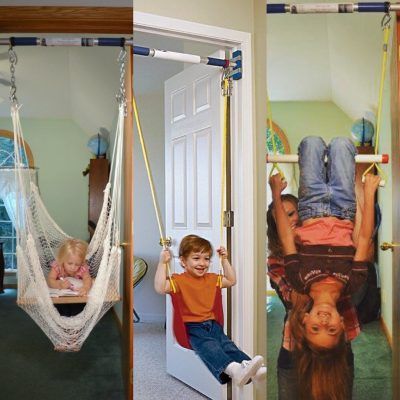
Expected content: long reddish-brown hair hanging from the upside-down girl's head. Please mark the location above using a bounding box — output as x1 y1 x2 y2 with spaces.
289 292 352 400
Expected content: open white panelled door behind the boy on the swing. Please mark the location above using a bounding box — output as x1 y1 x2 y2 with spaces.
165 52 226 400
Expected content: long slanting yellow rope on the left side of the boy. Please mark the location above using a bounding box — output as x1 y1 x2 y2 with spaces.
132 95 176 293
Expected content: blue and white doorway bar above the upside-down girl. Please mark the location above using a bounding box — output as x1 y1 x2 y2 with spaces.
267 2 400 14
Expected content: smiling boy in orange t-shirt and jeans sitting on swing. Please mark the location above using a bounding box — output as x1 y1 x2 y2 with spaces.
154 235 266 386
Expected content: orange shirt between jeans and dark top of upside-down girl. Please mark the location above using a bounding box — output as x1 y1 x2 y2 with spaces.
295 218 354 246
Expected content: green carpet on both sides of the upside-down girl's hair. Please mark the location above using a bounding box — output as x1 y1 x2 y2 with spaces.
267 296 392 400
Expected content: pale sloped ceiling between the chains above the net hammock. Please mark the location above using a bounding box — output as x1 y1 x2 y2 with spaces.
0 41 119 135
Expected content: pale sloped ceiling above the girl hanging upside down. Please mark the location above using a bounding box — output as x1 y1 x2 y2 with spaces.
267 1 382 119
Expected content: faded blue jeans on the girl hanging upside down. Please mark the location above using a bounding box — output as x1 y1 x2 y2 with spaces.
299 136 357 221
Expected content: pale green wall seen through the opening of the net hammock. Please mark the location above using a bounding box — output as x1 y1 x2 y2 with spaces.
0 117 91 240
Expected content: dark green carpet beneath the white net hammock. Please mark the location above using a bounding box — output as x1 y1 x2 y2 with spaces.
0 289 125 400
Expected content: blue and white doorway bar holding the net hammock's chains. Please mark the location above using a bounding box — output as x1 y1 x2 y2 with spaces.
0 37 133 47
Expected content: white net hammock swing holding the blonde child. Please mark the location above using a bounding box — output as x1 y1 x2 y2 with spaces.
0 50 126 351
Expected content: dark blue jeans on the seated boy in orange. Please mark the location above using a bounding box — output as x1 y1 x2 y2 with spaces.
185 320 250 383
